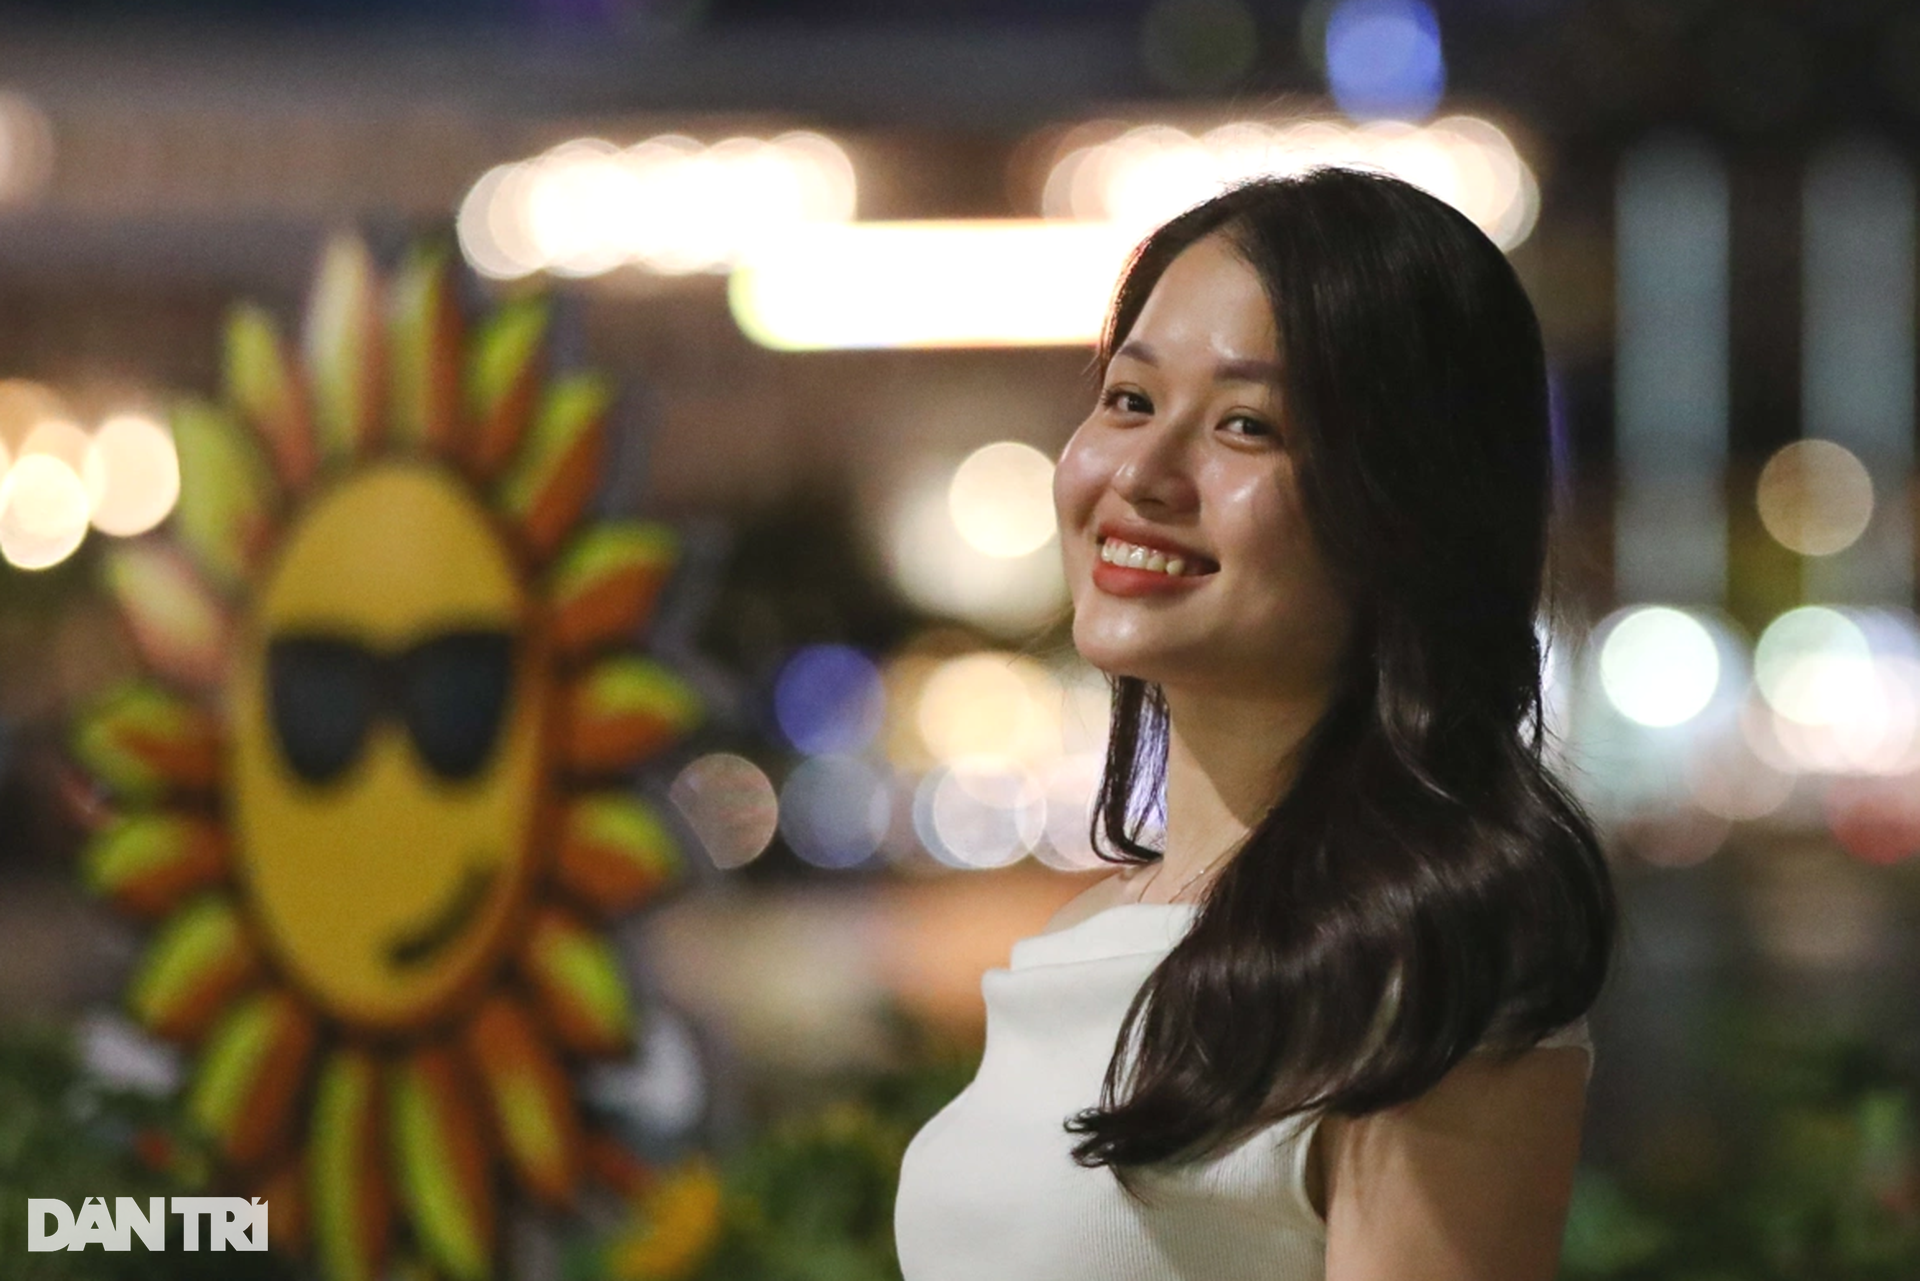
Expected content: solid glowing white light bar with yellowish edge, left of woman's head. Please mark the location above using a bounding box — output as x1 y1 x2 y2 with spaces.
728 219 1139 351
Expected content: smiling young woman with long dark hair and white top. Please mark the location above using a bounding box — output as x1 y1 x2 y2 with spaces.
895 169 1617 1281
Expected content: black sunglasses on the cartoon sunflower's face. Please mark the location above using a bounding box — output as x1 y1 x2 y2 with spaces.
267 628 515 784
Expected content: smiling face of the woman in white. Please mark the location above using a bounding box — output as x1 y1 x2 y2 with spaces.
1054 234 1350 697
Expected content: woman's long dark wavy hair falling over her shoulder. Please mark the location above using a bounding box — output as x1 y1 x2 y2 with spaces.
1066 167 1617 1196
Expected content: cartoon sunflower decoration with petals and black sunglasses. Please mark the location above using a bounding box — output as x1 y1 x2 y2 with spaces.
75 240 718 1281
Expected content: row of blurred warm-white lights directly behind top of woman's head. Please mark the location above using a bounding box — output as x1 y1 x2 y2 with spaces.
1041 115 1540 250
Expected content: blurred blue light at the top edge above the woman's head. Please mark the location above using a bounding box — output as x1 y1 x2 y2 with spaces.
1327 0 1446 119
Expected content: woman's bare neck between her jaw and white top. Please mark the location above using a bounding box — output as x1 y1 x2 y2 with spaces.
1148 689 1327 901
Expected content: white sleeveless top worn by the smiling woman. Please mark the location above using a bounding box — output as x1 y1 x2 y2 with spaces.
893 903 1594 1281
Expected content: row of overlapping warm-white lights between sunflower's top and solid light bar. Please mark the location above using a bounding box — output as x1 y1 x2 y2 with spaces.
455 131 856 278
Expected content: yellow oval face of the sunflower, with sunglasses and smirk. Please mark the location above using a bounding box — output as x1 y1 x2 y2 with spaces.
230 463 549 1027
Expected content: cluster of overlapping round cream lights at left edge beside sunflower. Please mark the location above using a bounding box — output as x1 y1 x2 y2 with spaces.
0 378 180 570
